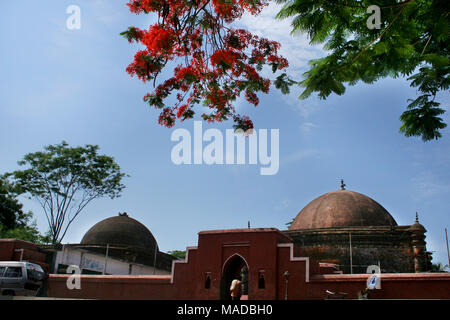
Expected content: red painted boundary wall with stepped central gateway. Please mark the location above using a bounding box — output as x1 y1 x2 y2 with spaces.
44 228 450 300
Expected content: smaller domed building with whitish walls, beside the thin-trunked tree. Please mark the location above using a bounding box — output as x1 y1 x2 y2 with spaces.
41 213 175 275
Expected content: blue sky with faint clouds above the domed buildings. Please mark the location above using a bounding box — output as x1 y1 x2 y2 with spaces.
0 0 450 263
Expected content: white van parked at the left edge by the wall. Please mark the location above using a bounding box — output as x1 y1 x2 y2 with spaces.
0 261 47 296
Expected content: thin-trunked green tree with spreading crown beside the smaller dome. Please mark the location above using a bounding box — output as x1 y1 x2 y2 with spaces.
6 141 125 243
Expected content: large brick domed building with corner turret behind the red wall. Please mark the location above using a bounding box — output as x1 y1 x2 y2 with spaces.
283 183 431 273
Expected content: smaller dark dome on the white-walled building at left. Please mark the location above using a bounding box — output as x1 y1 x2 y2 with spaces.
81 213 157 250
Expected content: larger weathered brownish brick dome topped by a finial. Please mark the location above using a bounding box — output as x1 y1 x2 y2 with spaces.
289 190 397 230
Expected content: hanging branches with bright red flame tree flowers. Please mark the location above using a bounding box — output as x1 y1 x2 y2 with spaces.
121 0 294 131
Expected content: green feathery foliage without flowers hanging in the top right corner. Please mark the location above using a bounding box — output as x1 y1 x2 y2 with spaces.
276 0 450 141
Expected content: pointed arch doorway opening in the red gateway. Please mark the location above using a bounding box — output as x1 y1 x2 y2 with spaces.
220 254 248 300
